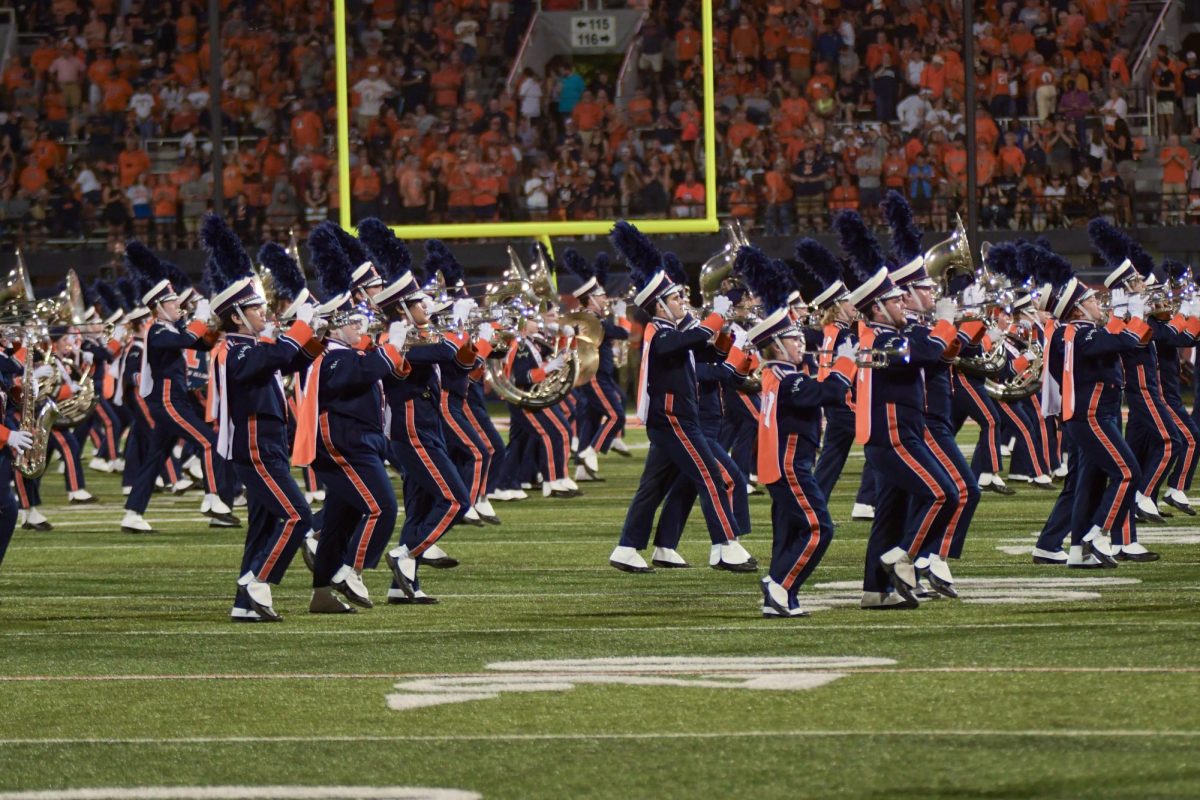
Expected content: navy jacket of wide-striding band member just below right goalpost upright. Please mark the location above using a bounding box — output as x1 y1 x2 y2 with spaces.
642 314 724 427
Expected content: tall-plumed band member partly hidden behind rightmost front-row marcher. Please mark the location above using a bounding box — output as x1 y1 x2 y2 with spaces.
1087 217 1183 532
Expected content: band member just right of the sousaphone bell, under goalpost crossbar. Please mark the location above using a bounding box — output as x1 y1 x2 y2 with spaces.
563 249 629 481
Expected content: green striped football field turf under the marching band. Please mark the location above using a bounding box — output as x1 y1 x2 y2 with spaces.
0 432 1200 799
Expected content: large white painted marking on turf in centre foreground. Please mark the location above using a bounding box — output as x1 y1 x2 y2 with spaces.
388 656 895 711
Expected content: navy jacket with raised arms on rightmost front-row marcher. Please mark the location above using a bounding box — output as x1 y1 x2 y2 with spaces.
1048 319 1150 420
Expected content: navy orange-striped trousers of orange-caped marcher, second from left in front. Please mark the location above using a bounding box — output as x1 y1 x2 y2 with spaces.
312 419 396 589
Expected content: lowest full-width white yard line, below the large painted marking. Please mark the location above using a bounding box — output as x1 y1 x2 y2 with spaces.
0 728 1200 748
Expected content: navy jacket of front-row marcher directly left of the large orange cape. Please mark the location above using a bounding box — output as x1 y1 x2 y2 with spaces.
224 321 312 464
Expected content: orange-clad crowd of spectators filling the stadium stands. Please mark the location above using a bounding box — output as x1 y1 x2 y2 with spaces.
0 0 1200 247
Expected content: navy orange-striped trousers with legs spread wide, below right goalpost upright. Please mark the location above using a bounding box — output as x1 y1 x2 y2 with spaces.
620 414 737 549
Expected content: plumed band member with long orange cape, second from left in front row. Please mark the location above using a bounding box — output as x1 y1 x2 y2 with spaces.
292 225 408 614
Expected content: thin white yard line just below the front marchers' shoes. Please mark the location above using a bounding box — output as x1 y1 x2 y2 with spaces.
0 619 1200 638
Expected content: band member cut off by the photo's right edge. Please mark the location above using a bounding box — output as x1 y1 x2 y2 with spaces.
1151 259 1200 517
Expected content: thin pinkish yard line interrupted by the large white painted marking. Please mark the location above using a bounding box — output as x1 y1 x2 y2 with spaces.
0 667 1200 684
